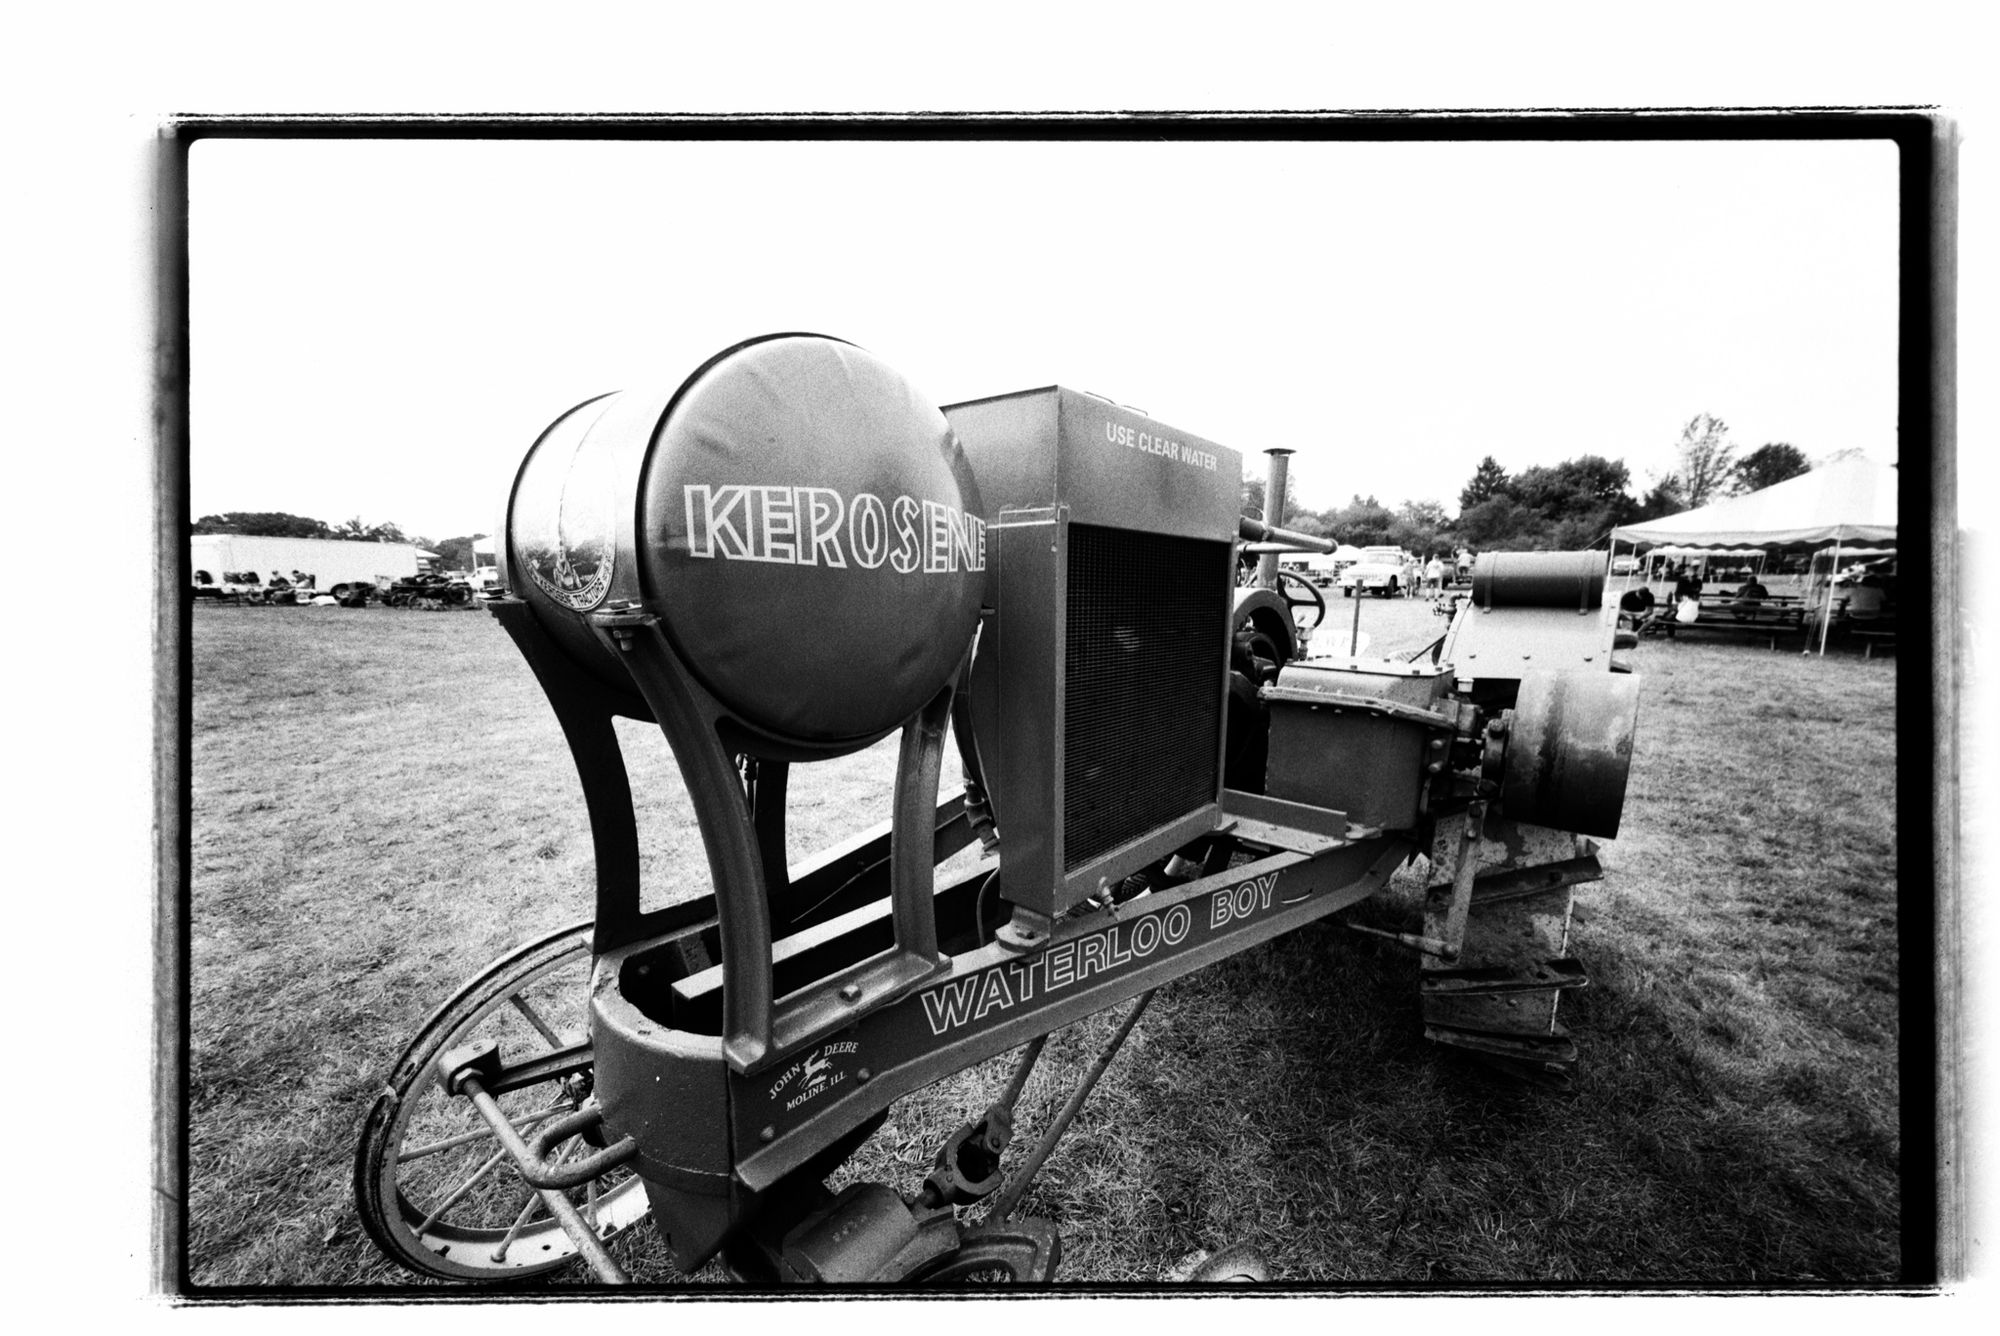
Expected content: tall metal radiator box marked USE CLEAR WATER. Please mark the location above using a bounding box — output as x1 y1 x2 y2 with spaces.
944 388 1242 914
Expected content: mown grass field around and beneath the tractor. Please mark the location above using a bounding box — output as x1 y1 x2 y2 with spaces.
186 598 1898 1286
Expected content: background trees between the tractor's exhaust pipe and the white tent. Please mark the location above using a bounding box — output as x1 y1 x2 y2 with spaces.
1244 412 1812 556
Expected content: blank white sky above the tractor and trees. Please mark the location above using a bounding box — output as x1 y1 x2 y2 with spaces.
188 130 1896 540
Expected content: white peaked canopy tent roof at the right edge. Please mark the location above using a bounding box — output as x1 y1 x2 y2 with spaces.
1612 458 1898 654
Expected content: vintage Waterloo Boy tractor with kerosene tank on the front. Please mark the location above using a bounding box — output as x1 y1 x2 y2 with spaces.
356 334 1638 1284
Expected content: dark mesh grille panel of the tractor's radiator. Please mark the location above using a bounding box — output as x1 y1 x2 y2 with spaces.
1062 524 1232 872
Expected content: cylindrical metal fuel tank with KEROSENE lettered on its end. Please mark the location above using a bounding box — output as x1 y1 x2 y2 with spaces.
504 334 986 748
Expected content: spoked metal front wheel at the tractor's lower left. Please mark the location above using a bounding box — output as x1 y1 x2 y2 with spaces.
354 922 648 1280
